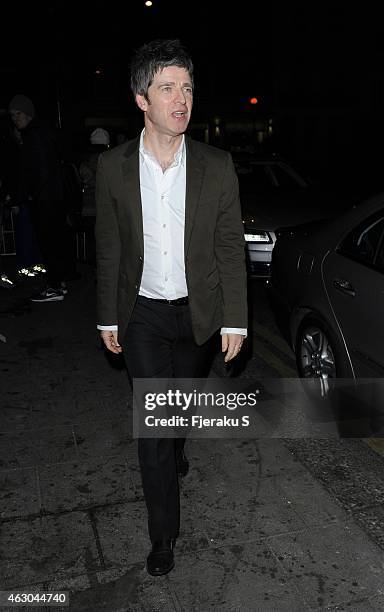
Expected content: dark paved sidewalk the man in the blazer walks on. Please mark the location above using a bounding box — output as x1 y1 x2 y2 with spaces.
0 262 384 612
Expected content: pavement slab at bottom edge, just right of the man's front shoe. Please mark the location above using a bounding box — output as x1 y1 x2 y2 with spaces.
169 542 304 612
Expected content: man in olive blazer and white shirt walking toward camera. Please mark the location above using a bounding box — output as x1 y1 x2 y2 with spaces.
96 40 247 576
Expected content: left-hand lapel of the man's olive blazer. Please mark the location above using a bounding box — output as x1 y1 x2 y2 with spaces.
122 138 144 254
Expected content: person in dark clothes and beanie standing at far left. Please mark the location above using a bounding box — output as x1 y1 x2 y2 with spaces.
8 94 67 302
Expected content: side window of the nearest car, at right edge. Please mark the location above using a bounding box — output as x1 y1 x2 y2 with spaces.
338 211 384 266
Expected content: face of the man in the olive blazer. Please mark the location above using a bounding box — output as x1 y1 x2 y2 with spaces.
136 66 193 136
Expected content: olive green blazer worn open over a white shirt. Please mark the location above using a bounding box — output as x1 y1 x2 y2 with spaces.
96 137 247 344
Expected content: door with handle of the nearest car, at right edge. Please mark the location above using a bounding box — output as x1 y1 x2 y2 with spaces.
323 211 384 377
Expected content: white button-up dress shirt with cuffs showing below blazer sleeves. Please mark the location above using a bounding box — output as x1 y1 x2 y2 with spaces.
97 130 247 336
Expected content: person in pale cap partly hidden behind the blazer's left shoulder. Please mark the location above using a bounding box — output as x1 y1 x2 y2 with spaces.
79 127 110 263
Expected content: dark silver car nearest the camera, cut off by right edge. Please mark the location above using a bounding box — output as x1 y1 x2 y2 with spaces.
271 194 384 386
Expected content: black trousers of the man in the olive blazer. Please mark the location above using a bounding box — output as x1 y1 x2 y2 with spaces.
122 296 213 542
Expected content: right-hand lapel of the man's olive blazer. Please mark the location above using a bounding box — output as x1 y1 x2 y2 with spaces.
184 137 204 255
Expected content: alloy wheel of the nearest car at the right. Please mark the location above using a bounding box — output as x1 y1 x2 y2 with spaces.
295 317 351 398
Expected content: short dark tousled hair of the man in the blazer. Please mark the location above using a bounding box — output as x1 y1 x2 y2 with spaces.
131 39 193 98
